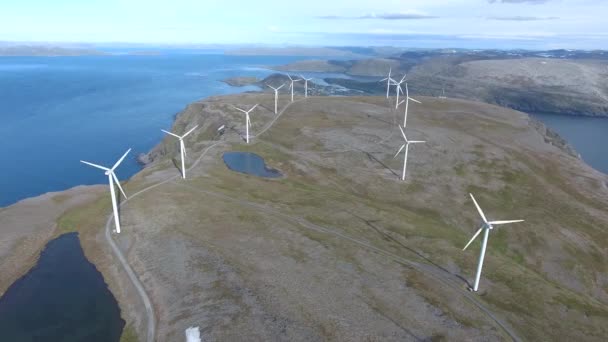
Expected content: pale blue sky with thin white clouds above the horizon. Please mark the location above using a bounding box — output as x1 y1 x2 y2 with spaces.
0 0 608 49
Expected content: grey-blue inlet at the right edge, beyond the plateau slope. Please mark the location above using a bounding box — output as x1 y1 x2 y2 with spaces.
532 113 608 174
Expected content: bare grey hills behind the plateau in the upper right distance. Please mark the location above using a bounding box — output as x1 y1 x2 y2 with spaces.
276 49 608 116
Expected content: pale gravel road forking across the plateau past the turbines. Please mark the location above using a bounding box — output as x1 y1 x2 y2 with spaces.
105 94 521 342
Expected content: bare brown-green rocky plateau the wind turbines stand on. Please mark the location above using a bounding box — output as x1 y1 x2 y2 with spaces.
0 93 608 341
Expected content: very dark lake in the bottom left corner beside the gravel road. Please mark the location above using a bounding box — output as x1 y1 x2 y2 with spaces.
0 233 125 342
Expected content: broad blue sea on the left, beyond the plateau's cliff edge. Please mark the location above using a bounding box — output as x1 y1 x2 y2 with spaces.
0 51 350 207
